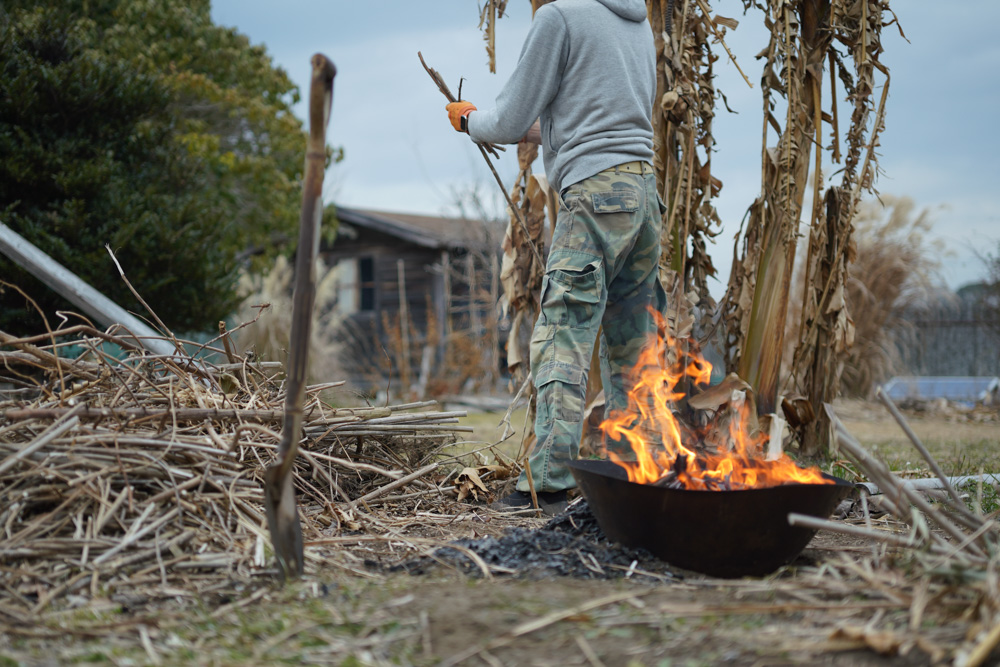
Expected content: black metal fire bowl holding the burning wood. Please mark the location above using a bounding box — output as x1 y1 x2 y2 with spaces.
569 461 853 577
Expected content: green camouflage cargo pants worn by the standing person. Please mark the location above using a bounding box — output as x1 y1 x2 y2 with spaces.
517 162 666 491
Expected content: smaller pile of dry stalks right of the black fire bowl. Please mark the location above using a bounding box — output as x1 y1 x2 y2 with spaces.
789 390 1000 667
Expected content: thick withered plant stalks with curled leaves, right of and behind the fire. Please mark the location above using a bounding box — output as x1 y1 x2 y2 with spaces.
723 0 889 451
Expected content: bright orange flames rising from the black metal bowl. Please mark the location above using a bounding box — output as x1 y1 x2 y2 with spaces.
600 318 833 491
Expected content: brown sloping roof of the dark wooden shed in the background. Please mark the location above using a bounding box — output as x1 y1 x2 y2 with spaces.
337 206 486 250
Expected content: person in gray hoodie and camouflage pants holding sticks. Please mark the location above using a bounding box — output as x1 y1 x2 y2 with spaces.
448 0 665 513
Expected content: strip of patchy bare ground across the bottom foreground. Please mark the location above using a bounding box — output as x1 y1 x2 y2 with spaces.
7 533 960 667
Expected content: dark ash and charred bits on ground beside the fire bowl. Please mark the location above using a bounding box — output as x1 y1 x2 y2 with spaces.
390 499 678 581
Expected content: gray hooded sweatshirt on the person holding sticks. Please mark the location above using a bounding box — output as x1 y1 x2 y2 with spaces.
468 0 656 190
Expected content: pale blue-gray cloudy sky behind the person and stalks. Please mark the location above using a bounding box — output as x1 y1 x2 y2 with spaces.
212 0 1000 295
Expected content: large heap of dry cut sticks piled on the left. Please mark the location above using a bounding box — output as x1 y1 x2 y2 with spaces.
0 327 467 612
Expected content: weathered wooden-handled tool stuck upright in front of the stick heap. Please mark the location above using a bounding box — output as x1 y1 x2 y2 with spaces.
264 53 337 581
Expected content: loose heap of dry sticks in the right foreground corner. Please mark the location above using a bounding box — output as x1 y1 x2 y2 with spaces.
789 390 1000 667
